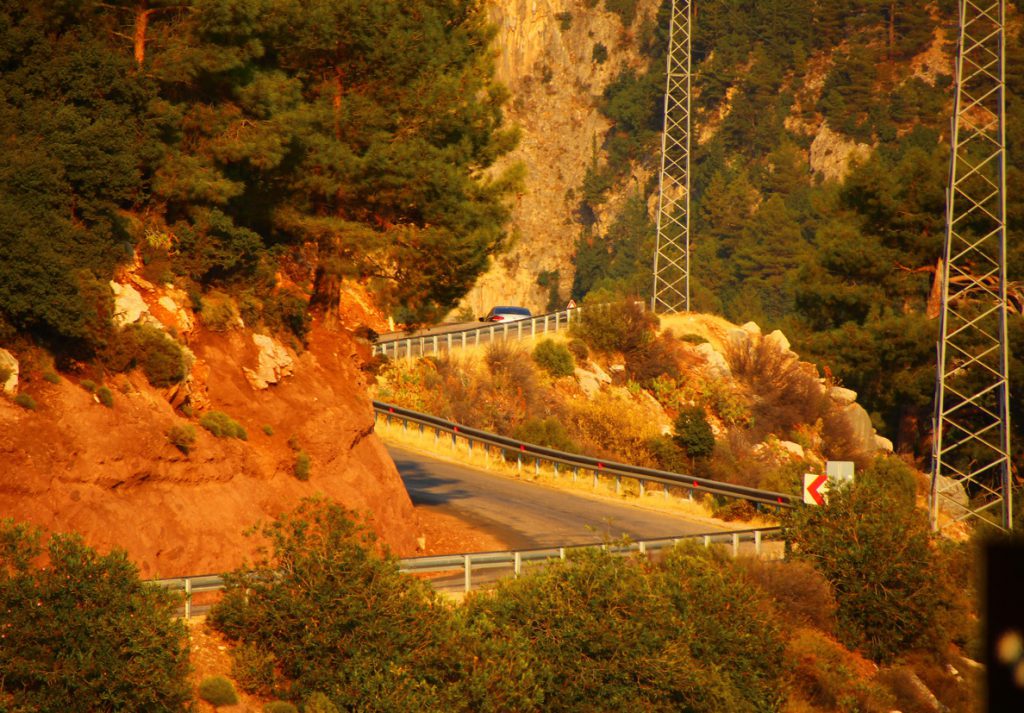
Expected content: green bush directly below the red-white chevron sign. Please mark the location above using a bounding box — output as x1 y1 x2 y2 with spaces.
785 459 954 662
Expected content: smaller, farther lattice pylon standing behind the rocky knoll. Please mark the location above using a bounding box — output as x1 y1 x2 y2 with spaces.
650 0 692 312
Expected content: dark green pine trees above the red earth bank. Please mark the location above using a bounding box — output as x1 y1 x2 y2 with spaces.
0 0 515 368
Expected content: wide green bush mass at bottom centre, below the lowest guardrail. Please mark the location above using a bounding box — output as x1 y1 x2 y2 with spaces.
466 549 784 712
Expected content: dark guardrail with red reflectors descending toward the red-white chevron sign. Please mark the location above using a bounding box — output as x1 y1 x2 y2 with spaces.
373 401 798 508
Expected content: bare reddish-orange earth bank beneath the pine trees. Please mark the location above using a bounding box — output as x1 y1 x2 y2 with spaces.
0 290 418 578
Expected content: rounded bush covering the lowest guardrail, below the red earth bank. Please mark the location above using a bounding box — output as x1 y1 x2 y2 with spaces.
210 499 469 711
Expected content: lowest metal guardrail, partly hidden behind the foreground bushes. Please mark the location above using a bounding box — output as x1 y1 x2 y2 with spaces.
148 528 781 619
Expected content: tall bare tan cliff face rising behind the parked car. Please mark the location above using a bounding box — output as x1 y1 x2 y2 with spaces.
462 0 659 314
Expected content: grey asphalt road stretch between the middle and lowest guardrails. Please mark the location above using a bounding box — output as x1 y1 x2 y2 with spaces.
387 445 724 549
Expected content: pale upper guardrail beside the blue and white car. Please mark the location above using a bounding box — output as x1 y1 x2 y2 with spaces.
373 307 583 359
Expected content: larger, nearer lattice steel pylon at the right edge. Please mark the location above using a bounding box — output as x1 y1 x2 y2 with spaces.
931 0 1013 530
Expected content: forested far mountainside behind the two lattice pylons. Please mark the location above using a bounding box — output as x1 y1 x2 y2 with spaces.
569 0 1024 457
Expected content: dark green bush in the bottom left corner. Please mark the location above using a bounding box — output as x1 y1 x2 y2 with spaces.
0 519 191 713
